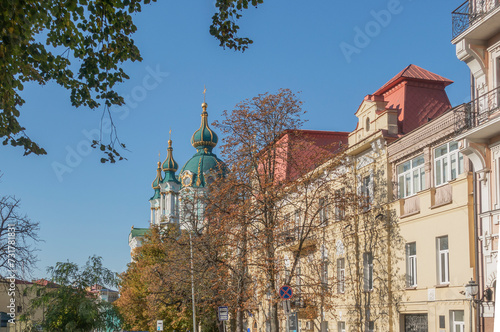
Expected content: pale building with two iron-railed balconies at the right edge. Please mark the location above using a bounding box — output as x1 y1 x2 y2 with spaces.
452 0 500 331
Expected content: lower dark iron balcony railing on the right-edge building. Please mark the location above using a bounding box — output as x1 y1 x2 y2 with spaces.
454 87 500 135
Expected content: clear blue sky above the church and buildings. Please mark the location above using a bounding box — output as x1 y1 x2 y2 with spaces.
0 0 469 276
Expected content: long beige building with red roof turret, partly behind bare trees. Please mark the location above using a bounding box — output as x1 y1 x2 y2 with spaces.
248 65 476 332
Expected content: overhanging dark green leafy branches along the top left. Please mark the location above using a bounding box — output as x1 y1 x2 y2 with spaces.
0 0 263 163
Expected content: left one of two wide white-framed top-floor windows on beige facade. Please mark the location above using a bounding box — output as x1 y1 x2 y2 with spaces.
397 155 425 198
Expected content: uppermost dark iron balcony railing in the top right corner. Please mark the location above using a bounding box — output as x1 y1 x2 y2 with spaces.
451 0 500 38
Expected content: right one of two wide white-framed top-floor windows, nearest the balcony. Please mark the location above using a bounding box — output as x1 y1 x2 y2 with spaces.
434 142 464 186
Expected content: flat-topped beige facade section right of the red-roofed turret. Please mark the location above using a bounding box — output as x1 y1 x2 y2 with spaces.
388 106 475 331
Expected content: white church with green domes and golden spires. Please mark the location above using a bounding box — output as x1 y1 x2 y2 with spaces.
129 102 226 255
